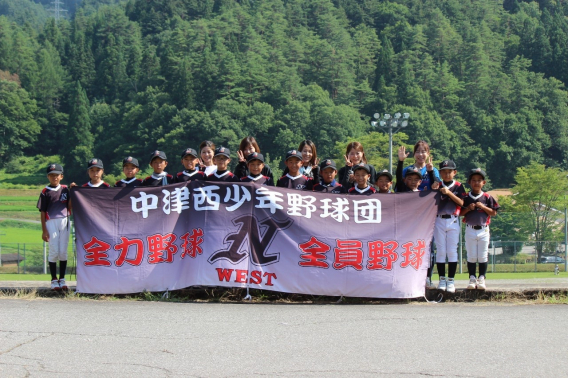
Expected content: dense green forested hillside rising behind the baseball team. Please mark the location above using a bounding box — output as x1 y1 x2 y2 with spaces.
0 0 568 187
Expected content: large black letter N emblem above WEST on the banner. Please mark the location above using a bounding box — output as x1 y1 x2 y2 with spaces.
208 214 293 265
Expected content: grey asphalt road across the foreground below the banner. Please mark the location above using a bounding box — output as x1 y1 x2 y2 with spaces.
0 299 568 377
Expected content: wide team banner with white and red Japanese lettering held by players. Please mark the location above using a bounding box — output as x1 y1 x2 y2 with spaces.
72 182 438 298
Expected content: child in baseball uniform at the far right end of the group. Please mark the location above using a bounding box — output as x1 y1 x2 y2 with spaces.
462 168 499 290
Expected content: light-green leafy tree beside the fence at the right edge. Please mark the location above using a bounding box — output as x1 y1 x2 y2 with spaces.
510 163 568 259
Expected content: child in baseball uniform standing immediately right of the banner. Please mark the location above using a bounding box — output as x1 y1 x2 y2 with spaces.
434 160 465 293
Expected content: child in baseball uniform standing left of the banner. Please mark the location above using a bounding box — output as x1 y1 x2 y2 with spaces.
37 164 69 290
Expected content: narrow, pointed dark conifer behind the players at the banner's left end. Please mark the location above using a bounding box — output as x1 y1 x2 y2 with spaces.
63 81 94 181
